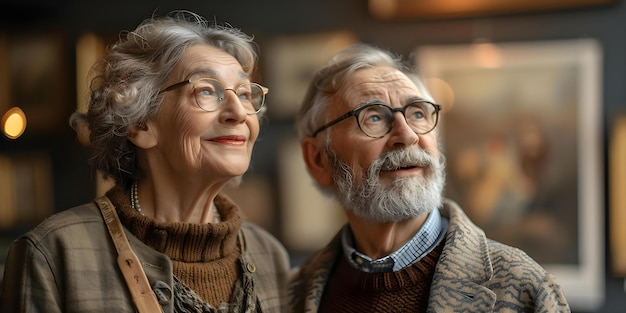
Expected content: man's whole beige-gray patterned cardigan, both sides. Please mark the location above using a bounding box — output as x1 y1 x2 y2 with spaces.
289 200 570 313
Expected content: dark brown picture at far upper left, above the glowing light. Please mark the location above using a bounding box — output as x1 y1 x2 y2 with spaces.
0 31 72 135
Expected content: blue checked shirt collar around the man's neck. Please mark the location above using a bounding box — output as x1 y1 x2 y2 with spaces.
341 210 448 273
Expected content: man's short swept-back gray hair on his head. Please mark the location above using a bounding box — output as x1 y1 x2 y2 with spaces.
296 44 432 144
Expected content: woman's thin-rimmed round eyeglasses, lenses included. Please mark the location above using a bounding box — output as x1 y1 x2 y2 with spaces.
159 78 269 114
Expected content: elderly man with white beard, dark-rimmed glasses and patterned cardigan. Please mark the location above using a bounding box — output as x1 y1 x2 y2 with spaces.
290 45 570 312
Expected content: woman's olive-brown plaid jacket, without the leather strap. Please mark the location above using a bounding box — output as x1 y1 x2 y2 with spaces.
0 184 289 313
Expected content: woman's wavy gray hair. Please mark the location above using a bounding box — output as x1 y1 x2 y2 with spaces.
70 11 258 186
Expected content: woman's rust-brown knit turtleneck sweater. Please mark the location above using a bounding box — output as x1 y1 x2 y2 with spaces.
107 186 243 307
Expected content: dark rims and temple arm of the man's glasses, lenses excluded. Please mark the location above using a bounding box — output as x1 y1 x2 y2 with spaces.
311 99 443 138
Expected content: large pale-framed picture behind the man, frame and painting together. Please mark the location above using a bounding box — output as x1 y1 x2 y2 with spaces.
415 39 605 310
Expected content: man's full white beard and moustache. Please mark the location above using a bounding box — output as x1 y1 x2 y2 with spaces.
327 146 445 222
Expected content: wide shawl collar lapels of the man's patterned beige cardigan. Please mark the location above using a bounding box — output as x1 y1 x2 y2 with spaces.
290 199 496 312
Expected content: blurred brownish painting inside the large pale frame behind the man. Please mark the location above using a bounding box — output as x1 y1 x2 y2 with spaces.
443 64 579 264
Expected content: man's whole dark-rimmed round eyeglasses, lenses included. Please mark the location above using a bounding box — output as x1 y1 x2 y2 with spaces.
311 100 442 138
